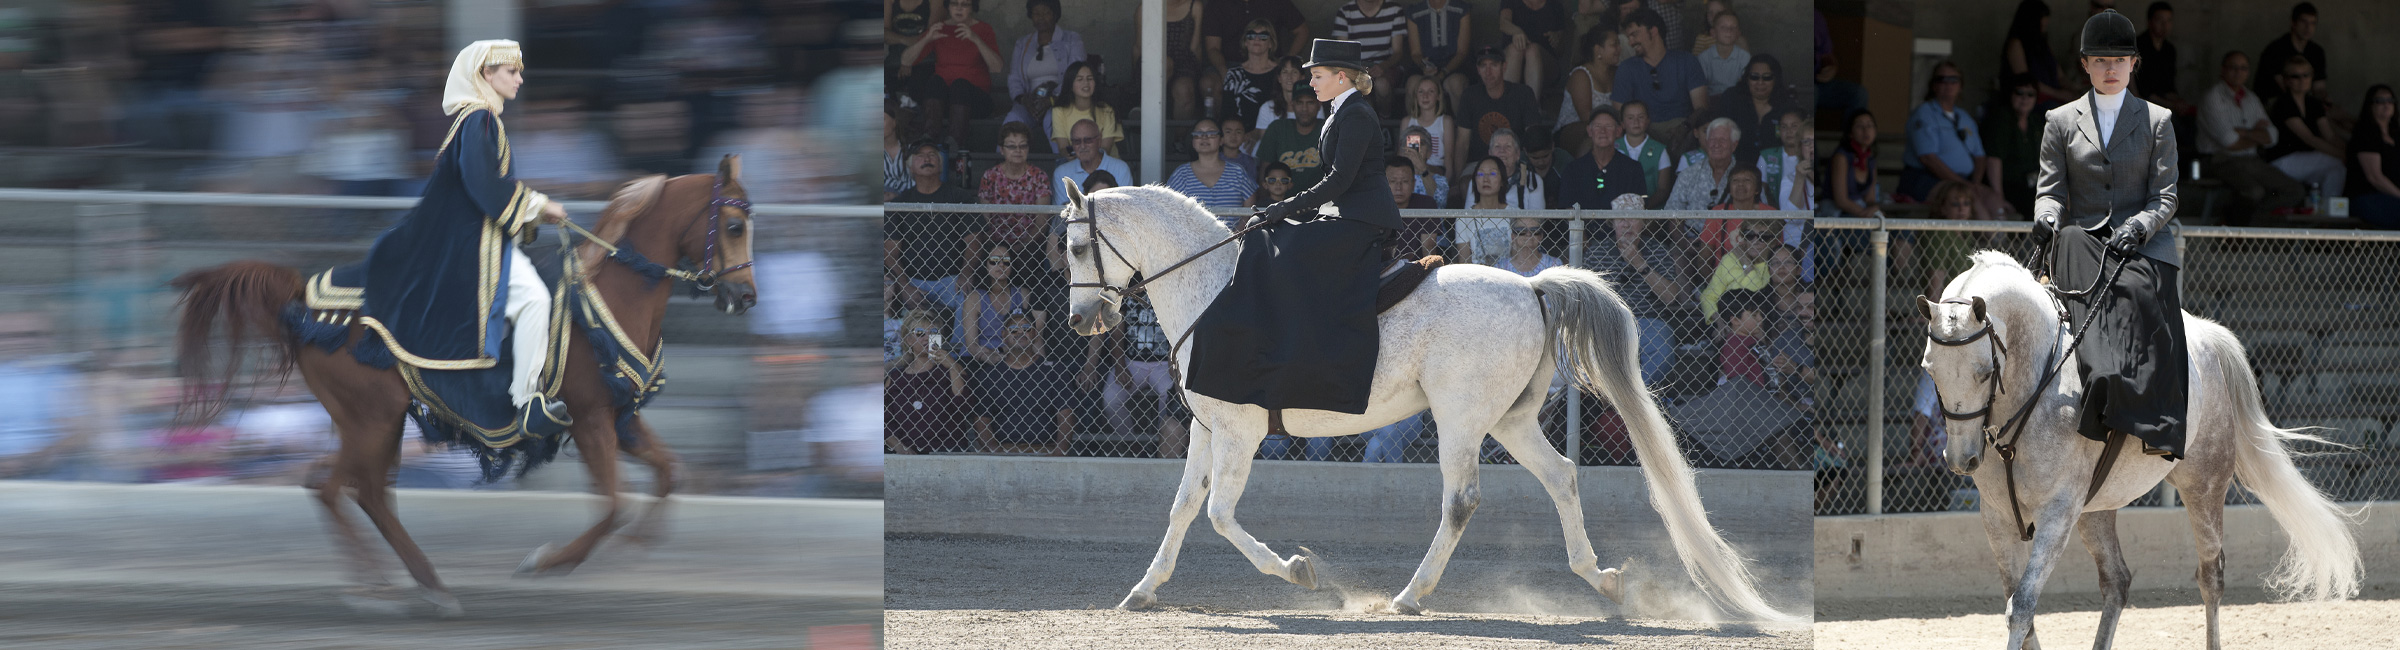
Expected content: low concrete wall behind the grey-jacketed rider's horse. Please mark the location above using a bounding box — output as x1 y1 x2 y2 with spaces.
1817 501 2400 602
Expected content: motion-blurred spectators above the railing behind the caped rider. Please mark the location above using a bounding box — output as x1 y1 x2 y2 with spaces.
0 0 876 204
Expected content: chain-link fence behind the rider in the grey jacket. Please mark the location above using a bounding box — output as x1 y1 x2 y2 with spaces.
1812 218 2400 516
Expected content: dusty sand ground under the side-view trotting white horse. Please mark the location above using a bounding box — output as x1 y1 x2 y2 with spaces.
883 534 1810 650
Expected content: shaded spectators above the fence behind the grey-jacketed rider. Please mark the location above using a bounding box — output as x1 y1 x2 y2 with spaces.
1819 0 2400 228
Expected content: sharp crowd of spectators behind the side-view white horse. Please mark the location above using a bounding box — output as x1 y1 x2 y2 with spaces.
883 0 1817 465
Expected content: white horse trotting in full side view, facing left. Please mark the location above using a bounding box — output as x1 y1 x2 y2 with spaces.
1063 182 1798 621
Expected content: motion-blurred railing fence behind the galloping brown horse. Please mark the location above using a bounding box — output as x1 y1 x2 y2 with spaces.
0 189 883 494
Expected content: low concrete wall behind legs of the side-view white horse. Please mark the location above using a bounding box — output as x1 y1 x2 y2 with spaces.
883 456 1810 554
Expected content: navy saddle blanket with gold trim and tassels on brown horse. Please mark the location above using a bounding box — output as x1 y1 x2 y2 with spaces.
283 240 667 480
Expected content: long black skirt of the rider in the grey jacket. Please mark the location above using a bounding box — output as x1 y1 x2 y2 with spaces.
2052 228 2191 458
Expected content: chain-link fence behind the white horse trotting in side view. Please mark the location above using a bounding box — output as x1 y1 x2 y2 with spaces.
883 204 1822 470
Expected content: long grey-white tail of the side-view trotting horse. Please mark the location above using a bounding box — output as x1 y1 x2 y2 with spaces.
1534 266 1805 621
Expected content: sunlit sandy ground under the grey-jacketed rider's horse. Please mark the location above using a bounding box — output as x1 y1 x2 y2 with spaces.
1817 585 2400 650
